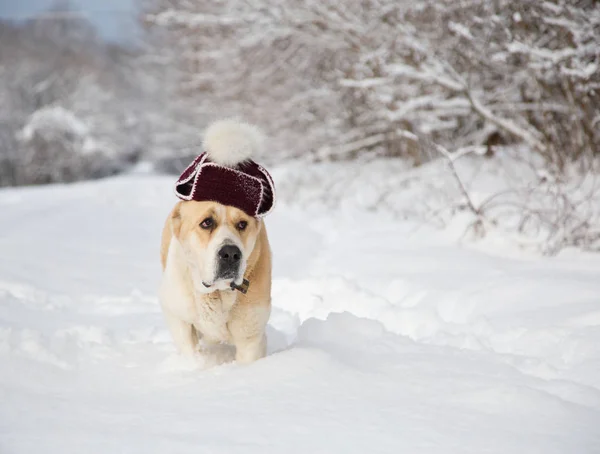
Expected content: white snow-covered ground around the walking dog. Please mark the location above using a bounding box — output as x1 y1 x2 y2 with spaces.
0 168 600 454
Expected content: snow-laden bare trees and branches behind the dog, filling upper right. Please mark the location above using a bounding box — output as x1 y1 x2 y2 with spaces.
145 0 600 170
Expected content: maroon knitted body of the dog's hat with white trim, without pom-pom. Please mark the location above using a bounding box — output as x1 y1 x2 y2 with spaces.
175 152 275 218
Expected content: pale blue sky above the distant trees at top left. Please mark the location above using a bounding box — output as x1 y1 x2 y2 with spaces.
0 0 138 42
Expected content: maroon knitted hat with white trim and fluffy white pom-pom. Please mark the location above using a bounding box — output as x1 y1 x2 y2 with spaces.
175 120 275 218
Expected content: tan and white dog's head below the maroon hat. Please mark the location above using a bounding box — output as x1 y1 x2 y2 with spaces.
171 201 262 293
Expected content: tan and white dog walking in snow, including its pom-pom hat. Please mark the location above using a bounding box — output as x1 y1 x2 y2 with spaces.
160 120 275 363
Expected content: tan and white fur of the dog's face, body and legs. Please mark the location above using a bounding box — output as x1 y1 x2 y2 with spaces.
160 121 271 363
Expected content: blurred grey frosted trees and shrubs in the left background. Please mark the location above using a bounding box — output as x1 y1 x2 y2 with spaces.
0 14 188 186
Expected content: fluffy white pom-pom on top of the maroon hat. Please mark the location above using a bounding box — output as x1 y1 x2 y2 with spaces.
204 120 264 167
